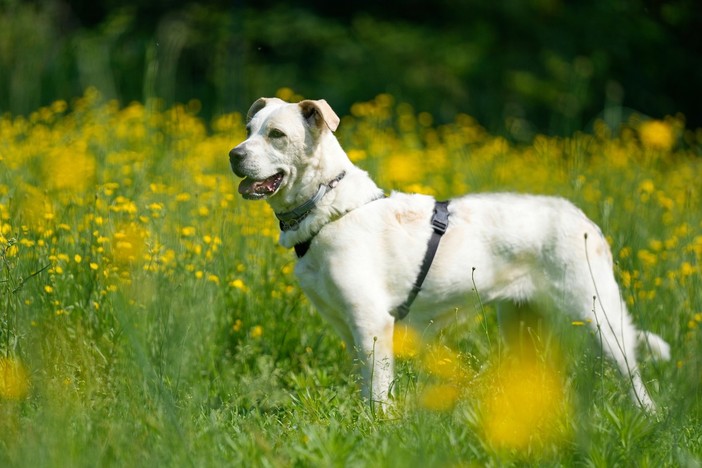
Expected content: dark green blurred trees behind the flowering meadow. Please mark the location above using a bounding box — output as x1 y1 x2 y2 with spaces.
0 0 702 141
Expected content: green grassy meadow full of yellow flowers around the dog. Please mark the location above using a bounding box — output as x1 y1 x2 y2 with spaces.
0 89 702 467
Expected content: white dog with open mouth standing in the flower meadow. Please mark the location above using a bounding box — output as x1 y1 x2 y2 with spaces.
229 98 670 410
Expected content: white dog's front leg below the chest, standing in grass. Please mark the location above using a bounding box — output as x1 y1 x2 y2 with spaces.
353 313 395 408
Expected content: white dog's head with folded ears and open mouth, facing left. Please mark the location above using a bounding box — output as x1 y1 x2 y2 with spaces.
229 98 339 200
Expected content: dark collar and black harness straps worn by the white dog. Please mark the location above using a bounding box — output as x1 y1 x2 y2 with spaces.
275 172 449 321
